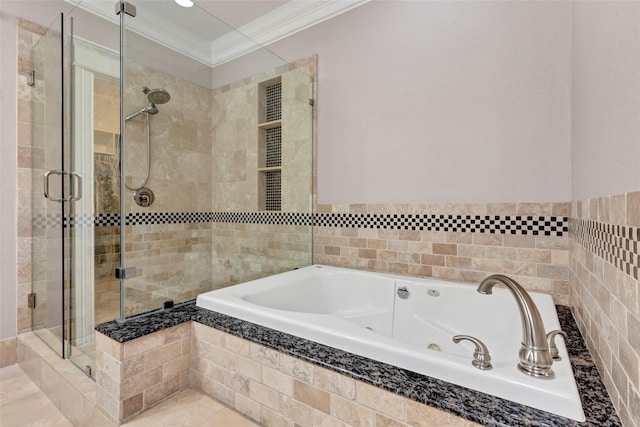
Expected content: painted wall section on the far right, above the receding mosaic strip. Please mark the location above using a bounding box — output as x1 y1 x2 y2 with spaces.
571 1 640 200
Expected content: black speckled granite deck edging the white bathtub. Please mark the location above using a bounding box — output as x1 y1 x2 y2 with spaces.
96 301 622 427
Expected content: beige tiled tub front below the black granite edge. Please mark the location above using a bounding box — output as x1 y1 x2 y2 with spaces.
95 321 477 427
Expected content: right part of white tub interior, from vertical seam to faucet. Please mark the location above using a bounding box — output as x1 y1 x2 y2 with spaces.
392 280 544 365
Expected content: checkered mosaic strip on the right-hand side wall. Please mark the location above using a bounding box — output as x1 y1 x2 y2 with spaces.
569 218 640 280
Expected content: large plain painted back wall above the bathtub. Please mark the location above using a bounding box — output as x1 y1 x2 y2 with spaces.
268 1 571 204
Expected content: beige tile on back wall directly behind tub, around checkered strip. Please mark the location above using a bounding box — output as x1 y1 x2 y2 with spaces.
313 203 569 304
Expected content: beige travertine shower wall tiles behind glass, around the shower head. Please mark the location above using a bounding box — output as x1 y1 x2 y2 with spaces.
117 57 316 315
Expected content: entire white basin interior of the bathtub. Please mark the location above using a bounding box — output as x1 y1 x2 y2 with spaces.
241 268 561 363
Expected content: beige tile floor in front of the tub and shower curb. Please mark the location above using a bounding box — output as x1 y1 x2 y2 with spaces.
0 365 259 427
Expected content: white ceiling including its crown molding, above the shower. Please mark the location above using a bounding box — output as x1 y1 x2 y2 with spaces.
65 0 369 67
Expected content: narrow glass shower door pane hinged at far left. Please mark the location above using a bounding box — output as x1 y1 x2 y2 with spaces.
30 14 71 357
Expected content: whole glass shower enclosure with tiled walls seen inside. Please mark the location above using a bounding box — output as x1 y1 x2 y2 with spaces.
27 0 316 375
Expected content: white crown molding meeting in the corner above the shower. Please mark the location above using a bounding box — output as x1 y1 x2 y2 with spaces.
65 0 370 67
